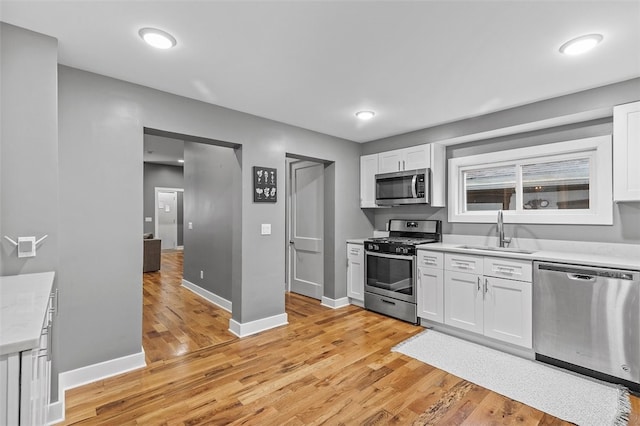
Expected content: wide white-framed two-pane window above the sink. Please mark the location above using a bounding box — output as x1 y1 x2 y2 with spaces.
449 136 613 225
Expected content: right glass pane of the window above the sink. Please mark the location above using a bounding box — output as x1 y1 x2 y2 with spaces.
522 158 589 210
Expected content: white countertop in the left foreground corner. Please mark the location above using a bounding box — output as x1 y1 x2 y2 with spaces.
0 272 55 355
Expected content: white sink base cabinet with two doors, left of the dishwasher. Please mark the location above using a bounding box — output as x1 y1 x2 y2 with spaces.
438 253 533 348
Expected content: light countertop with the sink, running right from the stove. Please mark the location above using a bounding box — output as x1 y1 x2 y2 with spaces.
417 243 640 270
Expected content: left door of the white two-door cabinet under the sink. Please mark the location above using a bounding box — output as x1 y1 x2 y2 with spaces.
444 271 483 333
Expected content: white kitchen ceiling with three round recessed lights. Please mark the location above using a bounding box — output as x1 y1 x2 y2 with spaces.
0 0 640 142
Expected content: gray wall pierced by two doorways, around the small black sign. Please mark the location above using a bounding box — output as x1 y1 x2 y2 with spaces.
59 58 372 371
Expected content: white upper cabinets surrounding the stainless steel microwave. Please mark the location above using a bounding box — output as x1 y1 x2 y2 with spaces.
360 143 446 208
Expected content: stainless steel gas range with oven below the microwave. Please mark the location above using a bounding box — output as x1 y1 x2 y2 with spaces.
364 219 442 324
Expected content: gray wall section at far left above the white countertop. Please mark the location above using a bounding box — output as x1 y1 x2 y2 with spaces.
0 23 61 400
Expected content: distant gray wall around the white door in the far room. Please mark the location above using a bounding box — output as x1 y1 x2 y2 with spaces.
142 163 184 246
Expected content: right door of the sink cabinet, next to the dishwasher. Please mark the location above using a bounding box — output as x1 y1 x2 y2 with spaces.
483 277 533 348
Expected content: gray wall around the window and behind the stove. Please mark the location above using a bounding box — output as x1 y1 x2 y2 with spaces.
362 78 640 244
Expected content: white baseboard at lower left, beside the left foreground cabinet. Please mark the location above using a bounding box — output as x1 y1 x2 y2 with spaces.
47 348 147 425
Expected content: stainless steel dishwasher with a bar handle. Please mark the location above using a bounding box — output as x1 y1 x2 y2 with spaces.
533 262 640 391
